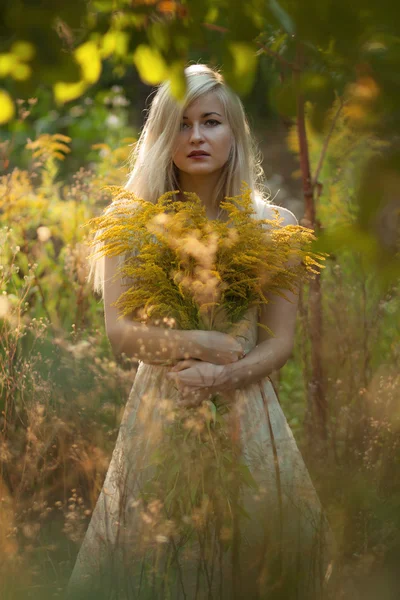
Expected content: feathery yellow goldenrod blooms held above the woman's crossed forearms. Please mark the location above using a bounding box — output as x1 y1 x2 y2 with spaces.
89 187 324 333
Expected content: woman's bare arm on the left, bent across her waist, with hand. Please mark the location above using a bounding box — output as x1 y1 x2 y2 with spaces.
104 256 242 364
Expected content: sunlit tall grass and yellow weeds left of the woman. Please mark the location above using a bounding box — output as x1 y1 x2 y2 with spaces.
0 136 135 599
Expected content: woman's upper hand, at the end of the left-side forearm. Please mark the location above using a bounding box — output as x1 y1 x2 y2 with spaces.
190 330 244 368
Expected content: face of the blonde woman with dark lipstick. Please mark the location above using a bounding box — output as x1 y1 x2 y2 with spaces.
173 92 233 175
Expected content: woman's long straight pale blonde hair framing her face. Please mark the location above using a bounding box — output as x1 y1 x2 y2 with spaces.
89 64 264 293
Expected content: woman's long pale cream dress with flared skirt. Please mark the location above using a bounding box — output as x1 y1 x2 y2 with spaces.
68 196 333 600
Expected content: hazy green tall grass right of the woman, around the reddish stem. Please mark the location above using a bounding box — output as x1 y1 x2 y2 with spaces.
279 117 400 600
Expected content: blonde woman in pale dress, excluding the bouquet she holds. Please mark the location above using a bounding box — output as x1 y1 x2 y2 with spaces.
69 65 331 600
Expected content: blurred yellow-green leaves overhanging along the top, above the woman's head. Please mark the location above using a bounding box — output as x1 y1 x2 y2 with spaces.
0 0 400 127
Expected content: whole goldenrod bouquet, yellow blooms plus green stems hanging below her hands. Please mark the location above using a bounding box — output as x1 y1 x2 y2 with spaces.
85 183 324 582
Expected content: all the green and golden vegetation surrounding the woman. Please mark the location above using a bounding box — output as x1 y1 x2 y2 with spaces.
0 0 400 600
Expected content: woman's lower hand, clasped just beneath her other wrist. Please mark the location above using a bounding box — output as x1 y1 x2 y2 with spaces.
167 359 226 407
